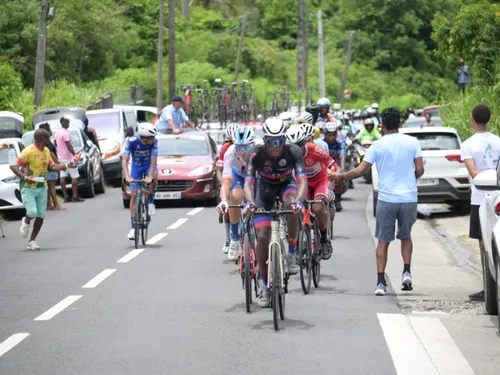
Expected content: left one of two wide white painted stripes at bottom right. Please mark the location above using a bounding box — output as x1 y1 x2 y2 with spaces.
377 314 439 375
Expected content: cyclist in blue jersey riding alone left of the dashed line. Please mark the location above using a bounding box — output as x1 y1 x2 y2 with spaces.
122 122 158 240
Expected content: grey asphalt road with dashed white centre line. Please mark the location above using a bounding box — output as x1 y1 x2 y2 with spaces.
0 182 496 375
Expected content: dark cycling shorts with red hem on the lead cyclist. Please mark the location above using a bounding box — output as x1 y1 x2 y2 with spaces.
253 178 297 229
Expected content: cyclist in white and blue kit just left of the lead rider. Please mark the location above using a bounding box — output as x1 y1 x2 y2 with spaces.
217 127 255 260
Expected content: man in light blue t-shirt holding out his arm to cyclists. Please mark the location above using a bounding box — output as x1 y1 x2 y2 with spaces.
332 108 424 296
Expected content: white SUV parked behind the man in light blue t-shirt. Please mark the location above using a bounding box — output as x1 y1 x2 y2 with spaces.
372 127 470 215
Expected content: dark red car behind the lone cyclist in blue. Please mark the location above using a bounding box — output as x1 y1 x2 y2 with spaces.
123 131 218 208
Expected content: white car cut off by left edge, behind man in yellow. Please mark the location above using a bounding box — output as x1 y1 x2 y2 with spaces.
0 138 24 211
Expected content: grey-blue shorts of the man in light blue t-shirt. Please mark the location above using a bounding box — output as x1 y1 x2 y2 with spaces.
375 200 417 243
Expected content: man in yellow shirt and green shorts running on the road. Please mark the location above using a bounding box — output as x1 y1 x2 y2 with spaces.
10 129 75 250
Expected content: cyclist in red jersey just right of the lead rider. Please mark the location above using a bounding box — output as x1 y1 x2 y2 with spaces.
286 124 338 260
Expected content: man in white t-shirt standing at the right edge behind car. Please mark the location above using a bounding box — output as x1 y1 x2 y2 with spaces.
461 104 500 301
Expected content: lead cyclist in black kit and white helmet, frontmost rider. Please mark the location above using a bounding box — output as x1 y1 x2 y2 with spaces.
244 117 307 308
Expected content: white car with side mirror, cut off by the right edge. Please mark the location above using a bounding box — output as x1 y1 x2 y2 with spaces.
473 170 500 330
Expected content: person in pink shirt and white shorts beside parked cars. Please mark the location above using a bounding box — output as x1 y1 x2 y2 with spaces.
56 117 85 203
